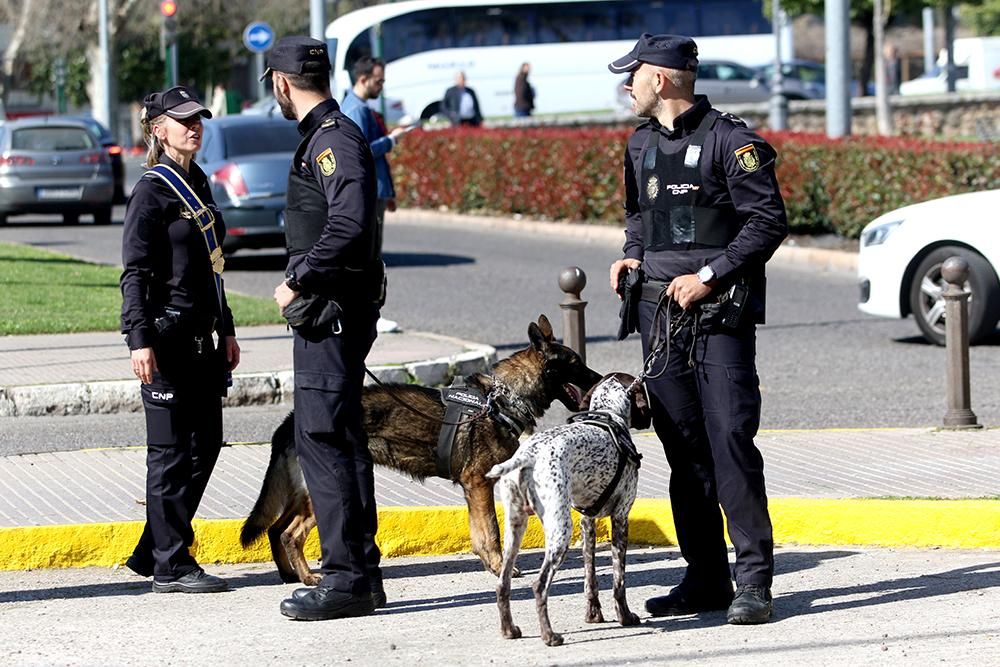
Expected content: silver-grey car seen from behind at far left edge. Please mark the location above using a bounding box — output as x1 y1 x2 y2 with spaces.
0 117 114 225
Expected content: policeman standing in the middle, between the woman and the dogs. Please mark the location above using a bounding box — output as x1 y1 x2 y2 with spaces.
265 37 385 620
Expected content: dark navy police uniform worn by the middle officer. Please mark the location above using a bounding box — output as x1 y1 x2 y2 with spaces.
285 99 384 595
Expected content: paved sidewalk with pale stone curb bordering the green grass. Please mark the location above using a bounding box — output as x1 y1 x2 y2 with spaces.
0 325 496 417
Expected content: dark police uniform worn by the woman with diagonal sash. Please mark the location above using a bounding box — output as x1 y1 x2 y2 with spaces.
121 155 235 580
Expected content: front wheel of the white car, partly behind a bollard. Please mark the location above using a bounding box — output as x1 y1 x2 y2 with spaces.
910 246 1000 345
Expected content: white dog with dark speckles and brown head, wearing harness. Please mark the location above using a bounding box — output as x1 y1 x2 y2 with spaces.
486 373 650 646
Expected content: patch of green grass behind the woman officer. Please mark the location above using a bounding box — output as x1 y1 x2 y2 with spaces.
0 242 284 336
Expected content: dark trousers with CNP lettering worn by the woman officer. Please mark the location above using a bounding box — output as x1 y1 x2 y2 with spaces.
134 360 222 580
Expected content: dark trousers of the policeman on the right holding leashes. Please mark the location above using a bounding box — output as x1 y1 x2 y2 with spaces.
639 301 774 587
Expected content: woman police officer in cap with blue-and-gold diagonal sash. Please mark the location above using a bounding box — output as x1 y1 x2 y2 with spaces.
121 86 240 593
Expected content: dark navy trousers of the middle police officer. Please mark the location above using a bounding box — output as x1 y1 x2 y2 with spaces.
294 306 382 594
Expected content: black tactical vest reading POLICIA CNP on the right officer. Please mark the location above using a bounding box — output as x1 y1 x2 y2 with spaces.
638 109 740 280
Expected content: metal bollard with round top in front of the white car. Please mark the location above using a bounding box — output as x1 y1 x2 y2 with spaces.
941 256 982 429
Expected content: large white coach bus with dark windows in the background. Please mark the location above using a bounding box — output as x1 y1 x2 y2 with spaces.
326 0 775 119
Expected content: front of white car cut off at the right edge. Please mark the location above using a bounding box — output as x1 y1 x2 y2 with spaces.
858 190 1000 345
